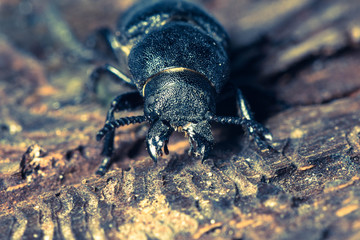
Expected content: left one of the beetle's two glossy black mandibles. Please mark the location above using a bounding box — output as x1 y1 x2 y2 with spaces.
146 120 174 164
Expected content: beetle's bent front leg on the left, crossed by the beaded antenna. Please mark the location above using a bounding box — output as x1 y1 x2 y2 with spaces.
96 91 142 175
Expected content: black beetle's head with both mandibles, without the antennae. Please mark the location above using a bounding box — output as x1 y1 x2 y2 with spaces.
144 70 216 161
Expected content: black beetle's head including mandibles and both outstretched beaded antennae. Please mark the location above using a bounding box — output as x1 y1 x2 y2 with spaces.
96 69 272 162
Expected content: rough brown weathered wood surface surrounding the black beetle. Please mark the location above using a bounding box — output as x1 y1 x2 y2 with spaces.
0 0 360 240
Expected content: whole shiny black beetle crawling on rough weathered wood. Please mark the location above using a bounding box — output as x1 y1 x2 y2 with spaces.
88 0 272 175
